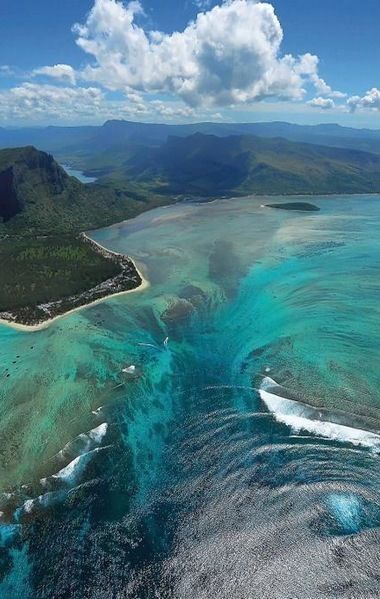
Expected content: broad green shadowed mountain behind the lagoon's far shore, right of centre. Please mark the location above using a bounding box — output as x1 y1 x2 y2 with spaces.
121 133 380 196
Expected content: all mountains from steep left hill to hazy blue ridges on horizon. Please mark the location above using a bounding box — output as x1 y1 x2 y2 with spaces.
0 121 380 235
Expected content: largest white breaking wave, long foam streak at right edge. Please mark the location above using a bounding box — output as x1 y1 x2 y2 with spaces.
259 377 380 452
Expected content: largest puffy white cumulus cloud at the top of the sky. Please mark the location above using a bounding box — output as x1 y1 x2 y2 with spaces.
74 0 333 107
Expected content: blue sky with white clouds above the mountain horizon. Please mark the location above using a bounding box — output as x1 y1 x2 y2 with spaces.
0 0 380 129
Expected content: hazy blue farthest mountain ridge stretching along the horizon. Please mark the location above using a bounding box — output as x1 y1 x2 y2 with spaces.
0 120 380 176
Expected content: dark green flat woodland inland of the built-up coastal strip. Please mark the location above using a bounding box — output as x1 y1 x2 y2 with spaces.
0 236 121 311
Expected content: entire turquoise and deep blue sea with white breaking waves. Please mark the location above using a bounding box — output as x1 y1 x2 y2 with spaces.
0 196 380 599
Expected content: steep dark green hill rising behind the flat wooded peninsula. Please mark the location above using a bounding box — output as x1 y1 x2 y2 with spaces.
0 146 169 236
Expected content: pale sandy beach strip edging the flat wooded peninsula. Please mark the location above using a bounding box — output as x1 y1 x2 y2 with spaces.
0 233 150 333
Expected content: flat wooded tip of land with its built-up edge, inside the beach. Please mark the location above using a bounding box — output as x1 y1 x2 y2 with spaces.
0 236 141 324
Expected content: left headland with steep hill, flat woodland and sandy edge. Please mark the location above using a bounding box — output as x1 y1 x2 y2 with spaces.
0 147 151 328
